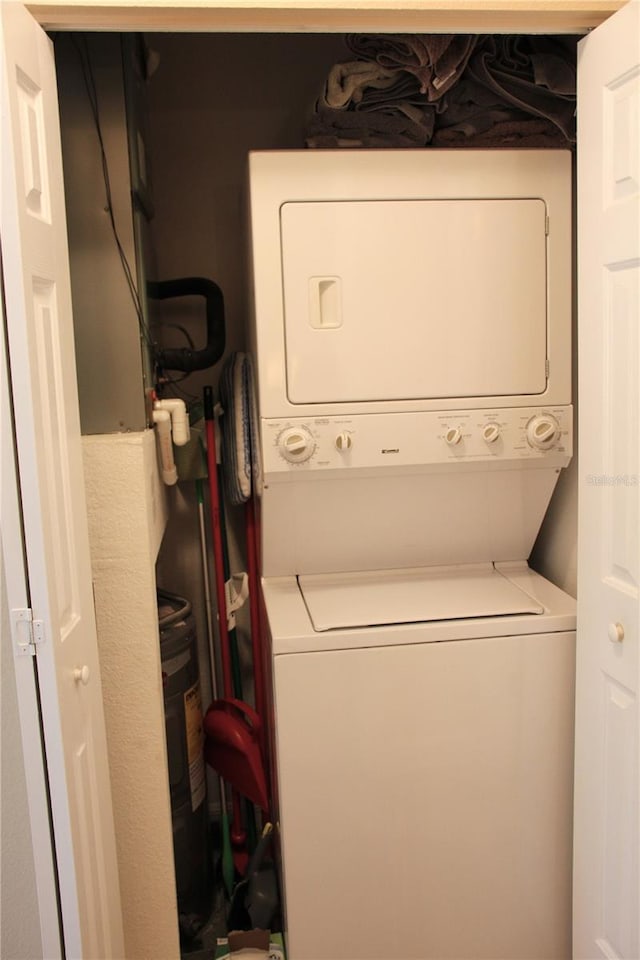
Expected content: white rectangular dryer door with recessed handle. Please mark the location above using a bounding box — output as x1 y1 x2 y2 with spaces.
280 198 547 404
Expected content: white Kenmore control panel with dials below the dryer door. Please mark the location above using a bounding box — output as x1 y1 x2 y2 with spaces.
262 406 573 477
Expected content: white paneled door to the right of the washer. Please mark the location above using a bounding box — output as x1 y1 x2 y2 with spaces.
574 0 640 960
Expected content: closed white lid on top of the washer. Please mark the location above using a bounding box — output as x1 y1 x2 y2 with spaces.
298 564 544 631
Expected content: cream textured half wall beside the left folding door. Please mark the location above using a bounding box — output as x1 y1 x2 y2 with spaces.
83 430 180 960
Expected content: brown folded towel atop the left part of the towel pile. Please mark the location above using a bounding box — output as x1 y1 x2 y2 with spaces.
346 33 477 101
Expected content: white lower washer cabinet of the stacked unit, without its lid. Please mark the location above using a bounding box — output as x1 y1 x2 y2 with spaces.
264 564 575 960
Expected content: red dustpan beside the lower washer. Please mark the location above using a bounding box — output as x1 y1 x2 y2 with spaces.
203 697 269 810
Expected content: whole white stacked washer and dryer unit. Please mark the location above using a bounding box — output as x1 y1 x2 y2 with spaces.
249 150 575 960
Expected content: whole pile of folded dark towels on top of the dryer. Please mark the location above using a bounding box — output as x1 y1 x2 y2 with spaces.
306 34 577 147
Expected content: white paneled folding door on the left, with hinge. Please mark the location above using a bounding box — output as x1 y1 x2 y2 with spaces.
0 3 124 960
